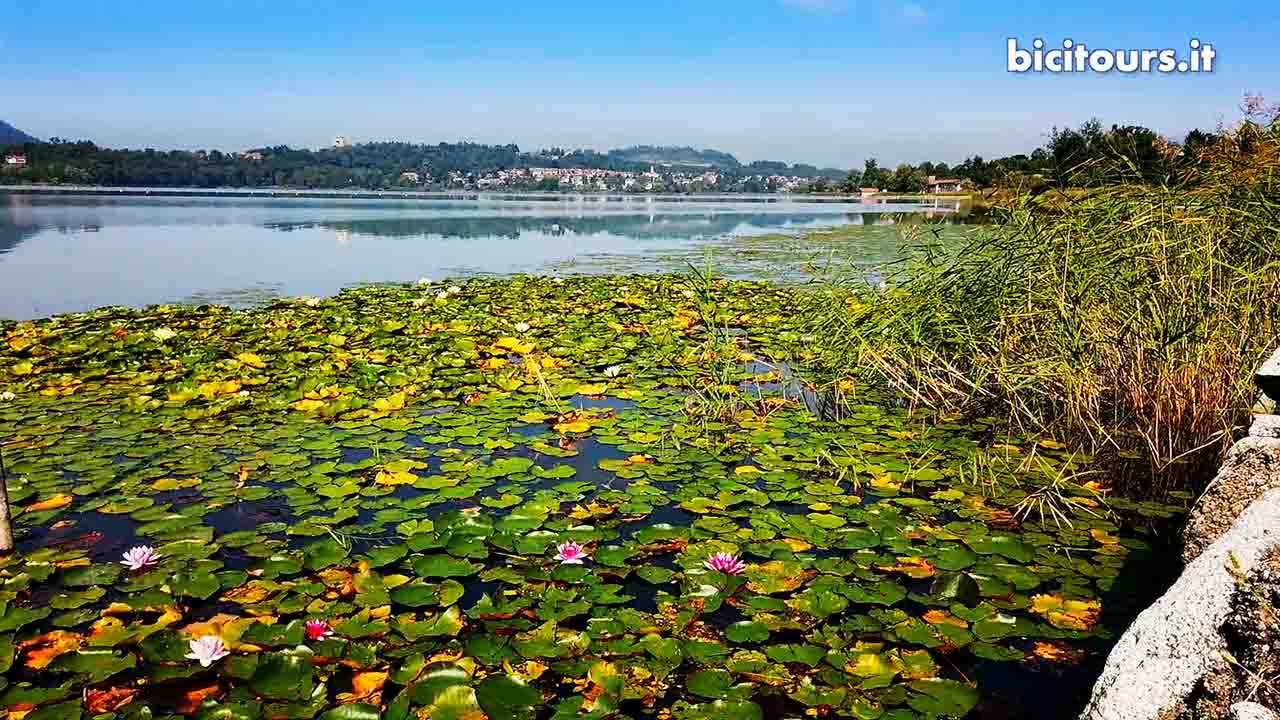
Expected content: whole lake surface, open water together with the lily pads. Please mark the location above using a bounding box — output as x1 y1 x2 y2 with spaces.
0 193 1180 720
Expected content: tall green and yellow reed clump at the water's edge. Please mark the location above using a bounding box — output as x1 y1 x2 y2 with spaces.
814 116 1280 492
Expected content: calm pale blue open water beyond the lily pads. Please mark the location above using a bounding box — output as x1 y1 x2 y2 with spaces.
0 192 957 319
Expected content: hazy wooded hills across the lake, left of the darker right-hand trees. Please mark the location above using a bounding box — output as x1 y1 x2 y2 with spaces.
10 137 844 192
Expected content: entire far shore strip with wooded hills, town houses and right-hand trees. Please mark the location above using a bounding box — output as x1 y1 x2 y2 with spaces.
0 120 1198 195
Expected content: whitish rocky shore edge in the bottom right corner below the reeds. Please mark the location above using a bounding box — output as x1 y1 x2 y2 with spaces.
1080 350 1280 720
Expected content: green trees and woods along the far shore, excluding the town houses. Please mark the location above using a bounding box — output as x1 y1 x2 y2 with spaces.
0 119 1217 192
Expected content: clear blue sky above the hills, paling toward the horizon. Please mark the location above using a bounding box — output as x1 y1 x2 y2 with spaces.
0 0 1280 167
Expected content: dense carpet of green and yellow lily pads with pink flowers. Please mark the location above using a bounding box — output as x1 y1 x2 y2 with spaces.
0 277 1176 720
